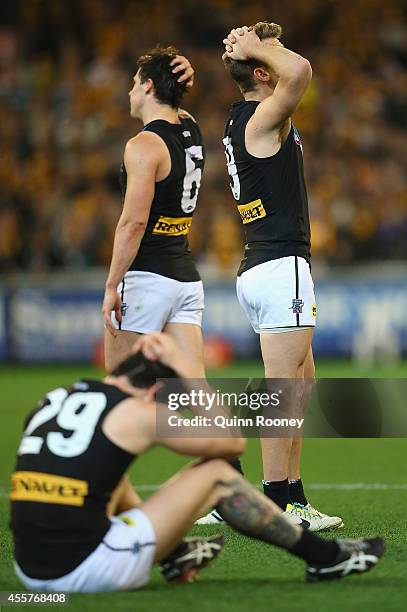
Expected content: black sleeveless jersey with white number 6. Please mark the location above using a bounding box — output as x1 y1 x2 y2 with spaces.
120 119 205 281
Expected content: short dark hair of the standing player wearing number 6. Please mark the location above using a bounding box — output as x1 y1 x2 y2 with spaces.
137 45 186 108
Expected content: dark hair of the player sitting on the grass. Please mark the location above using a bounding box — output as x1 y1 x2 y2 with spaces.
111 353 178 389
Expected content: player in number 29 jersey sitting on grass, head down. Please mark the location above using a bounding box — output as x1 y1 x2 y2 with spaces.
11 333 384 592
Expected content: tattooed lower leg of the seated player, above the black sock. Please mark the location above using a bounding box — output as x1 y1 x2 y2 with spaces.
216 478 301 549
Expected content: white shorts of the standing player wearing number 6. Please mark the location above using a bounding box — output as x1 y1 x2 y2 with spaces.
112 270 204 334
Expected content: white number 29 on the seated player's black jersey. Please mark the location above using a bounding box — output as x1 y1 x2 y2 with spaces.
18 389 106 457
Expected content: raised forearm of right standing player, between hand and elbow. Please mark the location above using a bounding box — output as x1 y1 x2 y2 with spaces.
252 40 312 82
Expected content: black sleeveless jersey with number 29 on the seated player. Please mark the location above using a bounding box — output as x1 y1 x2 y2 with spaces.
11 380 134 579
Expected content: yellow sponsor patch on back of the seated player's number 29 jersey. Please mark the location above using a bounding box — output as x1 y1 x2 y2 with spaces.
10 472 88 506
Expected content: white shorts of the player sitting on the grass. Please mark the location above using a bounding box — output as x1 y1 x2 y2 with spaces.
14 508 156 593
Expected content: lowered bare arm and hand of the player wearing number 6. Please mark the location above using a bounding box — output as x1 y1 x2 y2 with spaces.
102 132 168 335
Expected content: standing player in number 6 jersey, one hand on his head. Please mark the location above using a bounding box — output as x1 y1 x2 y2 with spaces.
102 47 205 378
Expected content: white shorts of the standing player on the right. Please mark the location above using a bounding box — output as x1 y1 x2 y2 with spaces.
236 256 316 334
